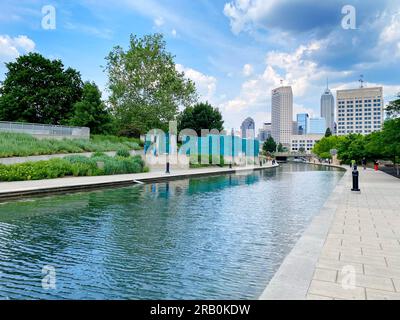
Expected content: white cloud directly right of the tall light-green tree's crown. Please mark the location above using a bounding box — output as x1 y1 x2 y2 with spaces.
176 64 217 103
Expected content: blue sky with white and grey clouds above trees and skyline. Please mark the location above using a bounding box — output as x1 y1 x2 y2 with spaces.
0 0 400 128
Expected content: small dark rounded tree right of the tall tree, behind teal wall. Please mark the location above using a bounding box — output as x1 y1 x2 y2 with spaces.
178 102 224 136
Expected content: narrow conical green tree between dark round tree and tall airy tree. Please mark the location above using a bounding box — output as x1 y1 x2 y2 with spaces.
69 82 112 134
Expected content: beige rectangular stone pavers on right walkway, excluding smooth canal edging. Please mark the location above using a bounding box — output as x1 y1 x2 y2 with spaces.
307 170 400 300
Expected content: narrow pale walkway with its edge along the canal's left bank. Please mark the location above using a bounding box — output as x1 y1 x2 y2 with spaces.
0 162 278 200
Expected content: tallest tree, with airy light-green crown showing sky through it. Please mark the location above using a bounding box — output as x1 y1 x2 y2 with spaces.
106 34 197 133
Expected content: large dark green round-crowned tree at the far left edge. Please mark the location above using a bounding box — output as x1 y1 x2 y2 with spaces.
0 53 83 124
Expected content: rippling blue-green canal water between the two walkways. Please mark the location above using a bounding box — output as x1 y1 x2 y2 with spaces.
0 164 343 299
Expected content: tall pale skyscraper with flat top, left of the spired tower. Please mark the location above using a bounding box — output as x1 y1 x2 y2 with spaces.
271 87 293 147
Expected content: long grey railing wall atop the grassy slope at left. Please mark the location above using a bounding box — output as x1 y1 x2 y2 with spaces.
0 121 90 139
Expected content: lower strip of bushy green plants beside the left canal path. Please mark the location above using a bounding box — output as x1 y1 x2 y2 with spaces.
0 153 148 181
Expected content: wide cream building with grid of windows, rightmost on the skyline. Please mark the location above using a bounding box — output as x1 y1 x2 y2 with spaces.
337 87 384 135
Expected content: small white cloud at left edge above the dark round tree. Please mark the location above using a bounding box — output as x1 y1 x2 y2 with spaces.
0 35 36 62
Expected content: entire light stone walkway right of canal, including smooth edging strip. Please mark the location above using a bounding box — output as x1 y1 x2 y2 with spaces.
260 169 400 300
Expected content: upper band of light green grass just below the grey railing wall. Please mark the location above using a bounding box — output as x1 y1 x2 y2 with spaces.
0 132 141 158
